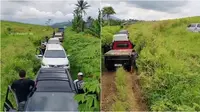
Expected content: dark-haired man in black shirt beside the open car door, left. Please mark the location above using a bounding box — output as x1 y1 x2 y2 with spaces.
11 70 35 110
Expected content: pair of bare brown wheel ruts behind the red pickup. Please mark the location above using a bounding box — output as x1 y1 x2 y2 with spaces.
101 72 148 111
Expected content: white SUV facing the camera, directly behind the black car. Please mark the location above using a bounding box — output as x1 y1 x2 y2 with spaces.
41 44 70 69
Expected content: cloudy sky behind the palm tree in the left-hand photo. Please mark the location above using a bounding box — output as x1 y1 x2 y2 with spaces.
1 0 100 24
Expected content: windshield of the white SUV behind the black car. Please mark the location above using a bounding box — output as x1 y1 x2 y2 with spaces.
44 50 66 58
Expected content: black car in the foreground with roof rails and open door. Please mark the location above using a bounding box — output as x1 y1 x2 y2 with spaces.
4 68 78 111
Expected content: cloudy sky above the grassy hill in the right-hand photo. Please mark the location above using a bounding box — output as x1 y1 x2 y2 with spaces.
101 0 200 20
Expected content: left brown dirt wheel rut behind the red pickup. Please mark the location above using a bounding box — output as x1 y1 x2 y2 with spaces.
101 72 116 111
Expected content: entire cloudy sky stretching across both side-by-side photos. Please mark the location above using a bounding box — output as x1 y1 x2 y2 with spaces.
1 0 200 24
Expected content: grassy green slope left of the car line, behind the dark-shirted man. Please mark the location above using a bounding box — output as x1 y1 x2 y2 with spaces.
1 21 52 109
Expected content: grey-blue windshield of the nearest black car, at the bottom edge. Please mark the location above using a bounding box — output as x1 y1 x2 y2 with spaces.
25 92 78 111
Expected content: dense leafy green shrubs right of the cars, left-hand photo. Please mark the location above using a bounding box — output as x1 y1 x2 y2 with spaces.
63 27 100 111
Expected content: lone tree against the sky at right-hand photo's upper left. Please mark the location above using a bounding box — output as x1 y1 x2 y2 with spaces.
102 6 116 25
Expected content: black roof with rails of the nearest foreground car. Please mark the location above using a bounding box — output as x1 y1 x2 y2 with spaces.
36 68 75 92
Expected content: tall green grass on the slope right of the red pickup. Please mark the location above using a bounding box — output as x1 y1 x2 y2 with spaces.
127 17 200 111
